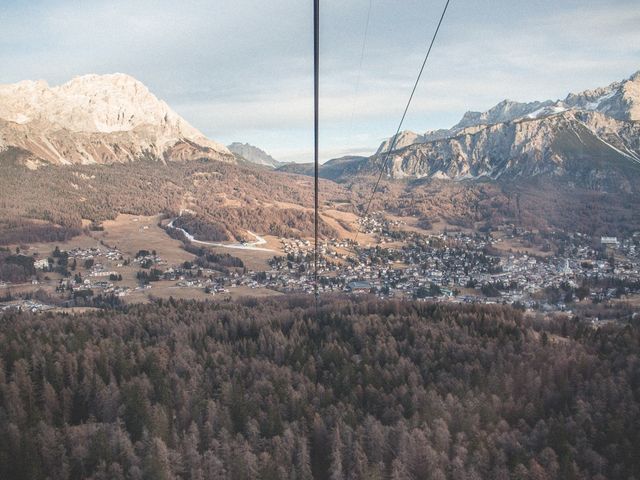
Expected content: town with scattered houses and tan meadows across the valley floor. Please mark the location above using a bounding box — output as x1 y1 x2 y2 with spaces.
0 212 640 322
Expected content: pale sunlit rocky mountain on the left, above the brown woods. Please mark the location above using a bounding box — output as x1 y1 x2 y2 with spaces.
0 73 234 168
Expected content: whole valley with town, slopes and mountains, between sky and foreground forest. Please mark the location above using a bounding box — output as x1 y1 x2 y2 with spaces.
0 69 640 320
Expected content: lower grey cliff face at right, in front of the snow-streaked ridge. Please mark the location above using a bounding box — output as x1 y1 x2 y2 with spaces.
370 111 640 190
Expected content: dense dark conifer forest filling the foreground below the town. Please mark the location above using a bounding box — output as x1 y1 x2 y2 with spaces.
0 298 640 480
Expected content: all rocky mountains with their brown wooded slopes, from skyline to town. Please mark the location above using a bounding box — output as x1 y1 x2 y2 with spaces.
0 72 640 238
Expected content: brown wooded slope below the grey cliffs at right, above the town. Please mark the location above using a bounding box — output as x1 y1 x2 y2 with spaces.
349 178 640 236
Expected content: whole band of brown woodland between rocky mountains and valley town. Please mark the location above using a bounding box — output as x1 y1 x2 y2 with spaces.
0 148 640 248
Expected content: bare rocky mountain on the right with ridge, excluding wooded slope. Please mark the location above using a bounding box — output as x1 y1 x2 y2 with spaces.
344 72 640 192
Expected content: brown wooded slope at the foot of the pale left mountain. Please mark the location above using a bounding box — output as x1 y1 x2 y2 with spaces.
0 152 348 245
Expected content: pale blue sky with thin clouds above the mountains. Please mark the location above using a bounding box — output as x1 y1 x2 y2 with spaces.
0 0 640 162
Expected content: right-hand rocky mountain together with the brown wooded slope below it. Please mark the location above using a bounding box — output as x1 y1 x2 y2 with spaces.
278 72 640 235
